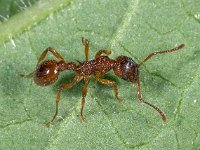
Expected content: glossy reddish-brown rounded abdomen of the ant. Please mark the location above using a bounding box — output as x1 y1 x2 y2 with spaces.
34 60 59 86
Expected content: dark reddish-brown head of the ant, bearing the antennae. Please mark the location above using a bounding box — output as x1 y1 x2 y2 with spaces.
113 56 139 82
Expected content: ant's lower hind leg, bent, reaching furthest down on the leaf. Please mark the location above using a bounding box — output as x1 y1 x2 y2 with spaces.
46 74 82 127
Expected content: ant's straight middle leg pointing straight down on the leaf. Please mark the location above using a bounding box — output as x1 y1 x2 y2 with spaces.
80 76 90 122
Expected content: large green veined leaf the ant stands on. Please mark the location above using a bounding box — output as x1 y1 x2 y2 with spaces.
0 0 200 150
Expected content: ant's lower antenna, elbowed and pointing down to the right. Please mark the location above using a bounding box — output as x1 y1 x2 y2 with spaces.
137 77 166 123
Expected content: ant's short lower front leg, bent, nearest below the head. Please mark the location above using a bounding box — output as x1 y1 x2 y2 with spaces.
95 75 122 101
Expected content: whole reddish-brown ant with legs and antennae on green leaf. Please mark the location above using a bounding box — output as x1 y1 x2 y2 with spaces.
20 37 184 127
